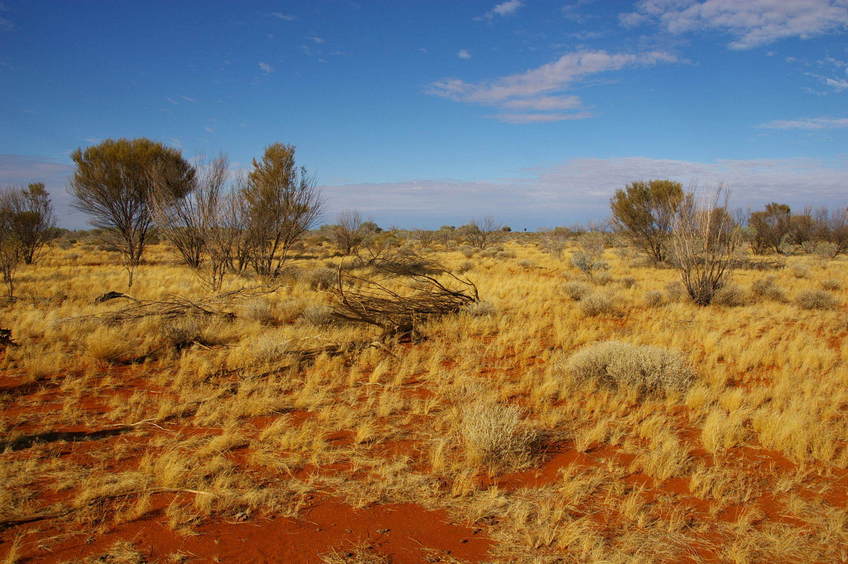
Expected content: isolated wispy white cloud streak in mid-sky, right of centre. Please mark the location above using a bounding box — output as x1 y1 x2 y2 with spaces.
427 51 677 123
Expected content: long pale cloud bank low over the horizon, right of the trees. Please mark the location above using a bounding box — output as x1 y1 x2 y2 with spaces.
322 157 848 228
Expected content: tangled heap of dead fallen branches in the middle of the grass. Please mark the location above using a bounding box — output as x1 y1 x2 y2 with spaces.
330 255 480 339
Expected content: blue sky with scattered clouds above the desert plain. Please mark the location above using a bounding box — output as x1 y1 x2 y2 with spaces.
0 0 848 229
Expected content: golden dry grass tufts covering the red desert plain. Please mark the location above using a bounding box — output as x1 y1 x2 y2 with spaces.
0 237 848 562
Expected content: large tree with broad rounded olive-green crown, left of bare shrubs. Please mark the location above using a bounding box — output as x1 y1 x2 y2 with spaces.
71 138 195 287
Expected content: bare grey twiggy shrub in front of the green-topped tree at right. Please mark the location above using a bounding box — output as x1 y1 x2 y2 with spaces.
669 188 740 306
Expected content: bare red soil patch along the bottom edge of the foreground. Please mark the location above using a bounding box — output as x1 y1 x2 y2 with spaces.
6 496 493 564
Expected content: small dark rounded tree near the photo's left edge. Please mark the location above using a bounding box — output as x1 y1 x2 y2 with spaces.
12 182 56 264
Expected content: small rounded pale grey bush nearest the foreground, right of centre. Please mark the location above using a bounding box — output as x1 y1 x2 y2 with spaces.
460 401 541 470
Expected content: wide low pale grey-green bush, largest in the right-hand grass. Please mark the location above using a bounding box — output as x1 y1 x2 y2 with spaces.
564 341 695 393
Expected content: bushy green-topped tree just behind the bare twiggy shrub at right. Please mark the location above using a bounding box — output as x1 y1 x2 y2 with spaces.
610 180 683 262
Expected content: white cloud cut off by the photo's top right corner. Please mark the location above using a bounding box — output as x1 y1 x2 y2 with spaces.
619 0 848 49
